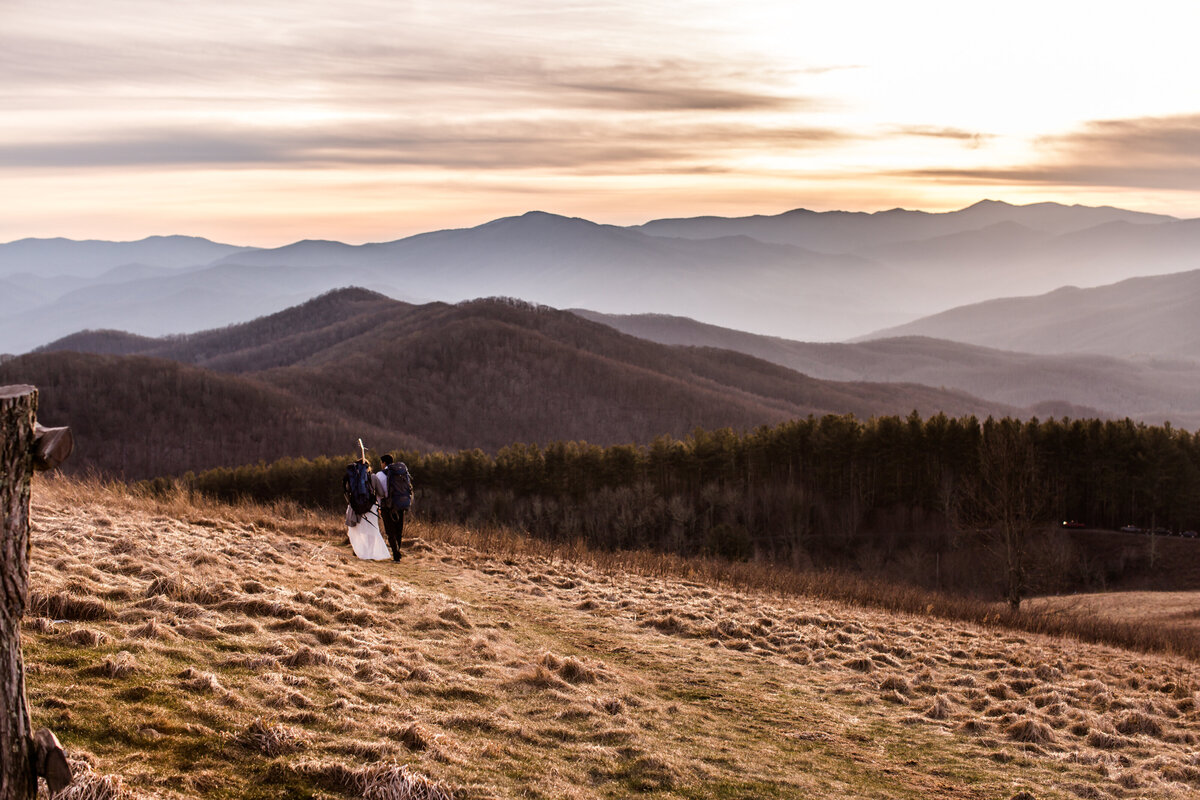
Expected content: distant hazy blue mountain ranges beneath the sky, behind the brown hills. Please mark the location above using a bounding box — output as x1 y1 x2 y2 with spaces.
0 201 1200 356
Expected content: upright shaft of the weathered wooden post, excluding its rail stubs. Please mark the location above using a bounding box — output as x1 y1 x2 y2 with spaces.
0 386 37 800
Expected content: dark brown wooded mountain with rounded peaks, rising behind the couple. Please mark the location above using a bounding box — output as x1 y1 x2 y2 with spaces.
11 289 1015 475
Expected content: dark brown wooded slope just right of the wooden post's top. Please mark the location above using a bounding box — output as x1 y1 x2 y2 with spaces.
0 353 430 479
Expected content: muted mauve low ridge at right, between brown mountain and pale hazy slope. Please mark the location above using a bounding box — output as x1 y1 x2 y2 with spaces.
576 311 1200 428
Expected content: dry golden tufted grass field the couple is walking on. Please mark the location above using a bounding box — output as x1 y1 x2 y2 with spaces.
23 479 1200 800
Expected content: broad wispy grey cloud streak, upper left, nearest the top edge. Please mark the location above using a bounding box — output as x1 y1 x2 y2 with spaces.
0 17 818 112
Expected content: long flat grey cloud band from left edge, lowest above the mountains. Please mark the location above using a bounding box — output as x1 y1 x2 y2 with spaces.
0 118 852 173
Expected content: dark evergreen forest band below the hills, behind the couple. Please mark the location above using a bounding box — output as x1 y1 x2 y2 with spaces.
180 413 1200 593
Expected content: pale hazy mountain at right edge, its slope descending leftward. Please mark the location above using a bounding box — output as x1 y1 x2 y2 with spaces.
864 270 1200 359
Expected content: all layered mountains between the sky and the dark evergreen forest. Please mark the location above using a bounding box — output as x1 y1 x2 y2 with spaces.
0 203 1200 477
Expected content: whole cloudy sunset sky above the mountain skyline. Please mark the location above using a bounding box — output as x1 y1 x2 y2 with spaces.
0 0 1200 246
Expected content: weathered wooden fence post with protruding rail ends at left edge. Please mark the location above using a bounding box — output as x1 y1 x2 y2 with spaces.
0 385 73 800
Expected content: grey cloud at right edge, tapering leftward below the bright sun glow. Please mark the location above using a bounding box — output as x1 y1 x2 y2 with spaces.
898 114 1200 191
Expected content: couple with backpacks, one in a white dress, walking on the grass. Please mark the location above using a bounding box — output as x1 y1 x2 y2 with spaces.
342 453 413 561
